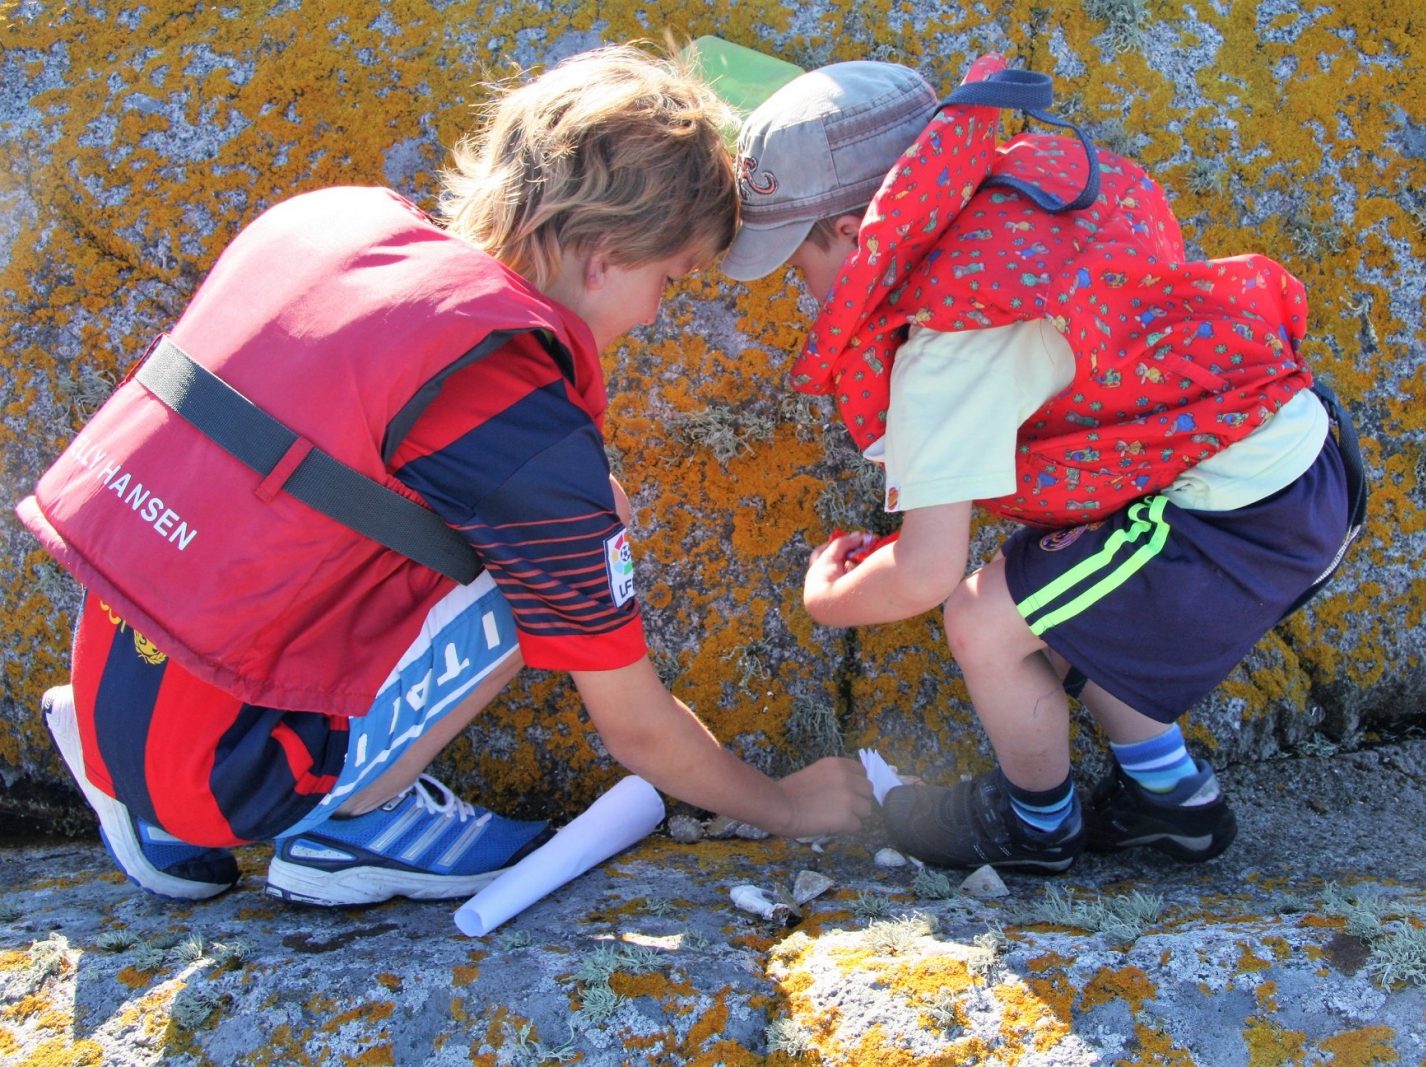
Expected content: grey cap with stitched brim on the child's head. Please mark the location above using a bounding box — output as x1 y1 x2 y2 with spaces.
720 60 938 281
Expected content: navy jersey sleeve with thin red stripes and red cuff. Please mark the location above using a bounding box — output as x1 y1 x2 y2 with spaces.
392 335 645 670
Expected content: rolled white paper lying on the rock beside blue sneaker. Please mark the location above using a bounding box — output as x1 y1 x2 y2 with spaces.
455 775 663 937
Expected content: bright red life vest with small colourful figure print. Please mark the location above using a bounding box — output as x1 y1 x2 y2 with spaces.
793 56 1312 526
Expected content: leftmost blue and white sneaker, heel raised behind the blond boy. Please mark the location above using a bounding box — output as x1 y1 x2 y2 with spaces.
43 685 238 900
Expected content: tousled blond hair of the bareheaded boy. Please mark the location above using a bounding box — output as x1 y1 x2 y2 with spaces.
441 46 737 288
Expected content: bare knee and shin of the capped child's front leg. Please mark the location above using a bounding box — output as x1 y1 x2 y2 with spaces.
945 556 1070 790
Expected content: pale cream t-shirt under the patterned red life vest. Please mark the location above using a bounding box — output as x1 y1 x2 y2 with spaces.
864 320 1328 511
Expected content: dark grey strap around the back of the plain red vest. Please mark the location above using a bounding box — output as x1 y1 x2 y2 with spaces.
134 337 481 585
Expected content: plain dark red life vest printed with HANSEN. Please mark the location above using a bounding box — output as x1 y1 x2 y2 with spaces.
19 188 606 715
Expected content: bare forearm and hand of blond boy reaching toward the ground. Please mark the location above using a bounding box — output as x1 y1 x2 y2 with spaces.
570 656 871 837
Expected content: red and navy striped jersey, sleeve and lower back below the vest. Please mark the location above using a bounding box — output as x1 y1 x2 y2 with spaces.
73 325 646 846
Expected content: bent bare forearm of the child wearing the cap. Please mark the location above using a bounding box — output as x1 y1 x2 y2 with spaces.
803 501 971 626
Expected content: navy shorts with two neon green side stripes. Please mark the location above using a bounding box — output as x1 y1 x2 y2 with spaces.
1004 435 1348 723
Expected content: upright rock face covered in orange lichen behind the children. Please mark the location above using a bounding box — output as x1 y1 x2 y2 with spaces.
0 0 1426 873
